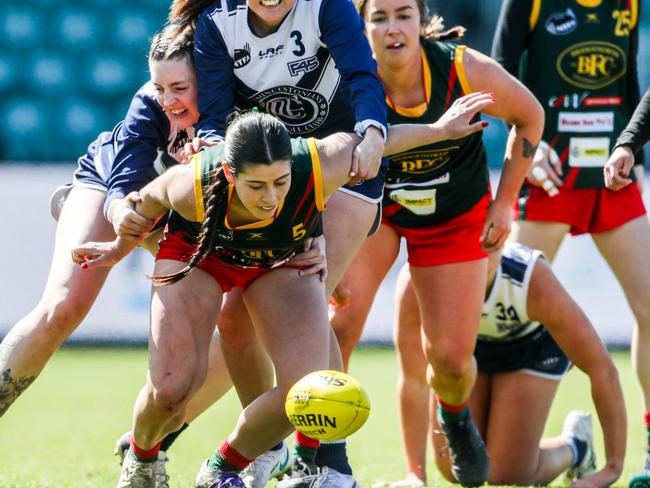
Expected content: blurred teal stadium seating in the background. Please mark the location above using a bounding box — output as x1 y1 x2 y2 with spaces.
0 0 650 167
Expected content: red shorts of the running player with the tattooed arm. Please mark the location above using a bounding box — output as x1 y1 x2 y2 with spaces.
382 195 491 267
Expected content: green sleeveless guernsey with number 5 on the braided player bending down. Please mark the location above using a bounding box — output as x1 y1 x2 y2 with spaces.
167 138 325 268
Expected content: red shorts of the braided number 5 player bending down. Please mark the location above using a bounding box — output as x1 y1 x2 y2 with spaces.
156 232 273 293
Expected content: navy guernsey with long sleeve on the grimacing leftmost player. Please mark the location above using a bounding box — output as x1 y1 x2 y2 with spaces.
83 82 194 215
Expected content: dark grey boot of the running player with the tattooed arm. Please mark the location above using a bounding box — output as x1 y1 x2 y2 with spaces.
438 414 490 486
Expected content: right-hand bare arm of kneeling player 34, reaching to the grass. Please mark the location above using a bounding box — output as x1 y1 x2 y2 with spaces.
528 259 627 486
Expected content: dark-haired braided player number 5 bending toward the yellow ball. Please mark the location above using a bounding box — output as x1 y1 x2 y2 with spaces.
73 107 491 488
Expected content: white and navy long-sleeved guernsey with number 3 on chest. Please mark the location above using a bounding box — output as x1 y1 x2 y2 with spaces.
194 0 386 139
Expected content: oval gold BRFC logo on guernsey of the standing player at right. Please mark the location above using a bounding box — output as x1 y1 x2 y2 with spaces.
556 41 627 90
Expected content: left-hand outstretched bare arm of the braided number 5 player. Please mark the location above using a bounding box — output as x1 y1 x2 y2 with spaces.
72 159 198 269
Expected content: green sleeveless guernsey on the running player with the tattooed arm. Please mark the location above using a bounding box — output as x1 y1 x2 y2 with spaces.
382 42 489 228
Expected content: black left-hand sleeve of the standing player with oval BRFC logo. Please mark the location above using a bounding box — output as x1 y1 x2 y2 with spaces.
492 0 533 78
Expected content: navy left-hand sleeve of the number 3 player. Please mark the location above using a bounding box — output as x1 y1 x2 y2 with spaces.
194 11 235 140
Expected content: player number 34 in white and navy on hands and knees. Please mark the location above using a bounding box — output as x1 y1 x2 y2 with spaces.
374 244 627 488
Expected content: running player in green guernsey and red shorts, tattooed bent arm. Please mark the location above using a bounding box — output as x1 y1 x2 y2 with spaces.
332 0 543 486
